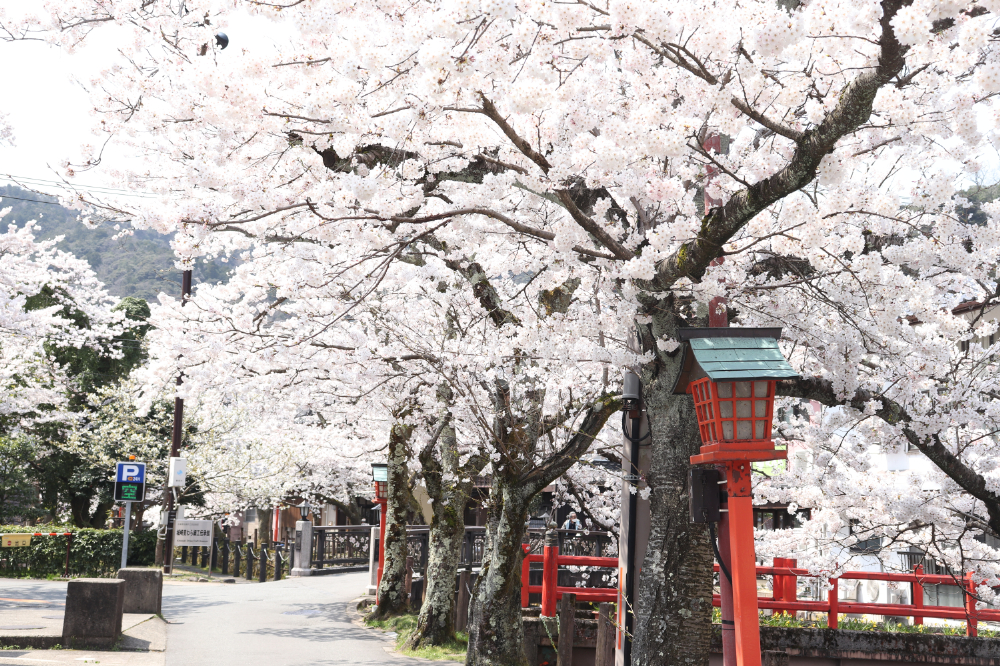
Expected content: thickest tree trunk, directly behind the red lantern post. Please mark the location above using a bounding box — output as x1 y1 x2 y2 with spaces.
632 301 712 666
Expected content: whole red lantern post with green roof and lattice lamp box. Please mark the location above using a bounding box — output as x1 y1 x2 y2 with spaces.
673 328 799 666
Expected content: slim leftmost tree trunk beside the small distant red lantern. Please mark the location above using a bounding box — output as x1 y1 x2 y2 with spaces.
372 423 413 619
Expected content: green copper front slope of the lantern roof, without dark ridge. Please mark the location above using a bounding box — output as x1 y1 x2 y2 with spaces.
690 338 799 382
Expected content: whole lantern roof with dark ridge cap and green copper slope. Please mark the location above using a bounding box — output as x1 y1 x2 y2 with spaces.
673 328 799 394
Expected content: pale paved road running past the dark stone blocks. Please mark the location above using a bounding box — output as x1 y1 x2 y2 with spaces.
0 572 418 666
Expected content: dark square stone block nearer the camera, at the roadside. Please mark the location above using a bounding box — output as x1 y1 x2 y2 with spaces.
63 578 125 648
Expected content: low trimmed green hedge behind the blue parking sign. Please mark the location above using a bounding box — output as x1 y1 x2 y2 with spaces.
0 525 156 578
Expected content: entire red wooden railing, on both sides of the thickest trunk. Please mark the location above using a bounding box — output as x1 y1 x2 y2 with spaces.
521 545 1000 636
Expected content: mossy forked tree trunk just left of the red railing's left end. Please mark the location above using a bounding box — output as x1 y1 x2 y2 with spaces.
465 474 533 666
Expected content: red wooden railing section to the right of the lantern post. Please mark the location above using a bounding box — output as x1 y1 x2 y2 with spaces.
712 558 988 636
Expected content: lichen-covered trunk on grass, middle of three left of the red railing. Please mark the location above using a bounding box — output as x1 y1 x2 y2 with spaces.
407 425 469 649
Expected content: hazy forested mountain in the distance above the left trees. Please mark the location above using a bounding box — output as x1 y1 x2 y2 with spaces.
0 185 230 301
